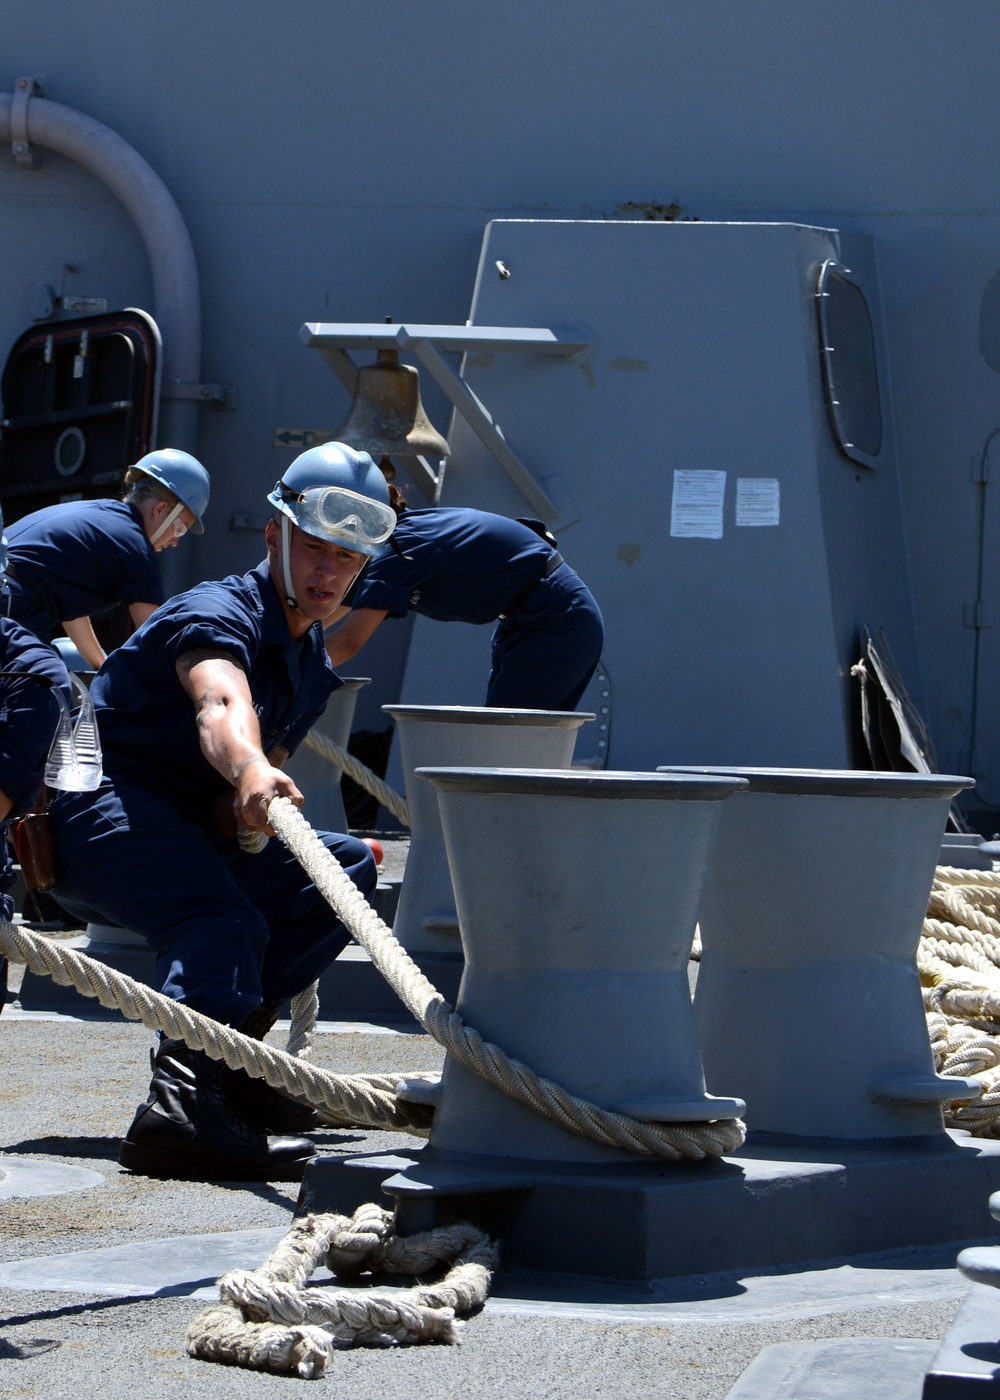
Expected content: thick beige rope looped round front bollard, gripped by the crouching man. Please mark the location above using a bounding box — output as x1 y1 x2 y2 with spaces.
0 798 745 1162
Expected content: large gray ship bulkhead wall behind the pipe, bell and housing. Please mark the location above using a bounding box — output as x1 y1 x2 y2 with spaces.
0 0 1000 787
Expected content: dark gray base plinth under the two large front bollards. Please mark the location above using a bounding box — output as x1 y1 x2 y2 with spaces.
297 1133 1000 1280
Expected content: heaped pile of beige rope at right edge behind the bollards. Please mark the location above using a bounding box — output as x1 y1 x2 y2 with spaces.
917 865 1000 1137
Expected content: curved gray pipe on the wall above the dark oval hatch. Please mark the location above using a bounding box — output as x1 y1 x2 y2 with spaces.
0 92 202 451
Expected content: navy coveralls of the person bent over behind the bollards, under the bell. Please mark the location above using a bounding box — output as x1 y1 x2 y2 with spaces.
346 505 604 710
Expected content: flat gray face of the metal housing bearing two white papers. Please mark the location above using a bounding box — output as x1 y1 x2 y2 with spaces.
403 221 913 767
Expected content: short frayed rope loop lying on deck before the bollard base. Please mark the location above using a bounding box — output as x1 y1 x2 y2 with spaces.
188 1205 497 1379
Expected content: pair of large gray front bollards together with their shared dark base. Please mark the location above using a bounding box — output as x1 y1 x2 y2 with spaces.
297 770 1000 1282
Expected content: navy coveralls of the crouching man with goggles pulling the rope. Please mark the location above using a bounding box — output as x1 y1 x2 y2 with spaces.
52 563 377 1025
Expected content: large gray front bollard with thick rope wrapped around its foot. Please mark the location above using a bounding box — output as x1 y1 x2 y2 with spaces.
408 769 744 1165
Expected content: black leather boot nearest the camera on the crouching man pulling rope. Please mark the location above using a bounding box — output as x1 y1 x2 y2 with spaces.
118 1040 315 1182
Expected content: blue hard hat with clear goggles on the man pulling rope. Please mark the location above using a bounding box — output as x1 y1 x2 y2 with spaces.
268 442 396 554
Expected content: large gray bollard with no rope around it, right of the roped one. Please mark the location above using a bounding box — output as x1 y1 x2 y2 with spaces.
658 766 979 1138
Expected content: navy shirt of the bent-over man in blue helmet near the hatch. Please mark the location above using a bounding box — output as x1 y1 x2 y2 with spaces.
7 500 164 641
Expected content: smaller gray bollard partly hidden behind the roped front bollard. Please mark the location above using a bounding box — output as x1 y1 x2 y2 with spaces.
382 704 594 957
